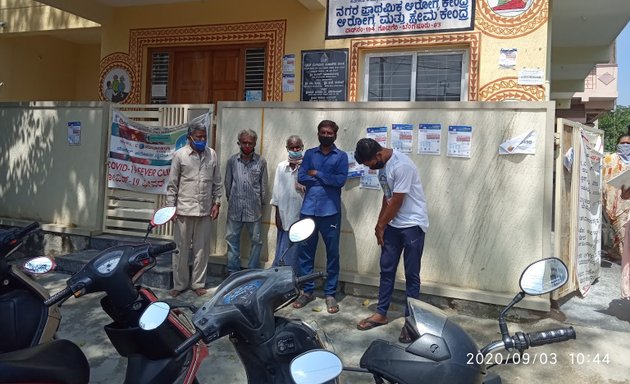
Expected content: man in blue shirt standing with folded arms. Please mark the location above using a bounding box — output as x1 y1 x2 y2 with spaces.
293 120 348 313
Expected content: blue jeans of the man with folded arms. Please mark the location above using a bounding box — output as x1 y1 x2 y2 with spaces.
299 213 341 297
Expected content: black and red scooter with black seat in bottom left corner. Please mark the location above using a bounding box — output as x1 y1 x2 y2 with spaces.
0 207 208 384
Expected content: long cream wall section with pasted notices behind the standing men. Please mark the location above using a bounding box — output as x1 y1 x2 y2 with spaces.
216 102 554 303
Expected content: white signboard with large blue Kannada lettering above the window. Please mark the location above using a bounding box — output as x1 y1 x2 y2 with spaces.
326 0 475 39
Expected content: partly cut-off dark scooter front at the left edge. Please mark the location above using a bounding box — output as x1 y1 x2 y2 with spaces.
0 222 61 353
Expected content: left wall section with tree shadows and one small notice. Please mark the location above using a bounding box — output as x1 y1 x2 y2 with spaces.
0 102 109 231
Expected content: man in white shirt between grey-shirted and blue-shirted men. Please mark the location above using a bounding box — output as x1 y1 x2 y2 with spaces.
271 135 305 272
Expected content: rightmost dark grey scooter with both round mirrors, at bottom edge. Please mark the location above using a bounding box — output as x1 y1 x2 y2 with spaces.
291 258 576 384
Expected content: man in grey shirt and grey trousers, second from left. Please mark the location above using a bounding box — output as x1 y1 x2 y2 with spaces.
225 129 267 273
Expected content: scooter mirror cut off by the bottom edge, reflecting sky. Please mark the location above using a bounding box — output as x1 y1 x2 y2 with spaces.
291 349 343 384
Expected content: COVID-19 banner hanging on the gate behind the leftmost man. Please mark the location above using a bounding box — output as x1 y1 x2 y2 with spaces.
107 110 210 194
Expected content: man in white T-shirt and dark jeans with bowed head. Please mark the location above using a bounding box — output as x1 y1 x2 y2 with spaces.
354 139 429 343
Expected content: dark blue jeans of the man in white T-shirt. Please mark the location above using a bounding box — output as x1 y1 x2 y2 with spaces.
376 225 424 316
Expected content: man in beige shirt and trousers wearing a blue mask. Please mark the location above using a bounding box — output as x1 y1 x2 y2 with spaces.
166 124 221 297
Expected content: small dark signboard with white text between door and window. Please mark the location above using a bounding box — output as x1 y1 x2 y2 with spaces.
300 49 348 101
